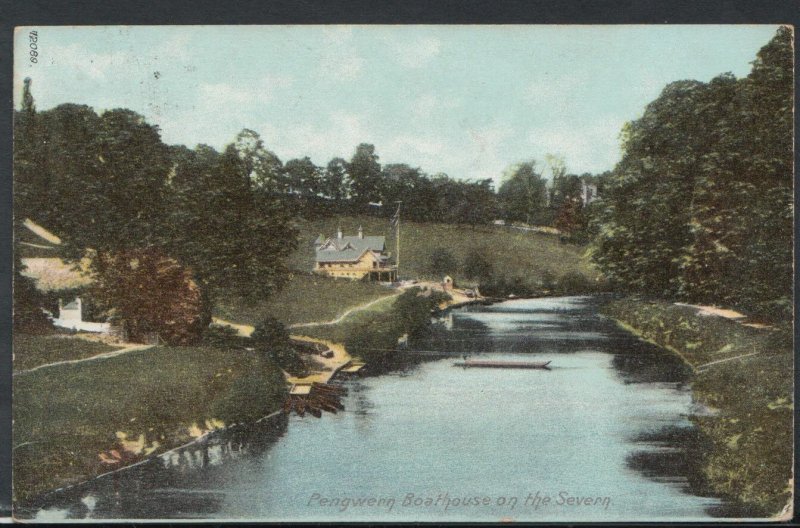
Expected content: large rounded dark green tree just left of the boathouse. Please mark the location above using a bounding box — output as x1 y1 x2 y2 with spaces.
167 145 297 298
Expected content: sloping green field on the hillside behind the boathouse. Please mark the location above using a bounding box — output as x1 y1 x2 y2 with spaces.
290 216 599 283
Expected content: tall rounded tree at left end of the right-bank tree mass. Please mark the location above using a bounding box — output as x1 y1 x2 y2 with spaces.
594 81 720 298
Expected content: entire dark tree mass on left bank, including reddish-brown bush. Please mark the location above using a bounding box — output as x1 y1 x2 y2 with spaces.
14 86 297 343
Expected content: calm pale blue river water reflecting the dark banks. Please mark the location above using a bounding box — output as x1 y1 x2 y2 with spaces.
31 297 721 522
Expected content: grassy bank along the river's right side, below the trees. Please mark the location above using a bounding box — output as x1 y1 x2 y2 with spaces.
603 299 794 517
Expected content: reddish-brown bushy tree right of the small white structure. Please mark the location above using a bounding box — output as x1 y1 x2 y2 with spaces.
91 249 211 345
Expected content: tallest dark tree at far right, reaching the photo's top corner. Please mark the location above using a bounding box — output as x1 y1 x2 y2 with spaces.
681 28 794 319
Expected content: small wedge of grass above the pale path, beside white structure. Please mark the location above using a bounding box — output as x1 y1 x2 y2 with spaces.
13 333 119 371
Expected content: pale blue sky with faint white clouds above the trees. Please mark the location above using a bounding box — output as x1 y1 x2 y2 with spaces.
14 25 778 186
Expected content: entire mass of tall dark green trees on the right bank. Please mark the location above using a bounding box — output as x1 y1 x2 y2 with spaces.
594 28 793 318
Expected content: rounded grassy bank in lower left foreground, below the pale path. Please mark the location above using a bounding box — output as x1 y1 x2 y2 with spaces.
13 336 286 501
